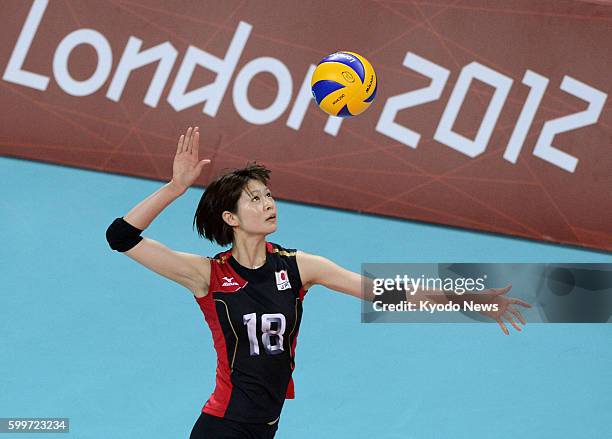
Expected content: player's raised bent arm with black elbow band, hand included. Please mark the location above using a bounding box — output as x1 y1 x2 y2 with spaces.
106 127 210 296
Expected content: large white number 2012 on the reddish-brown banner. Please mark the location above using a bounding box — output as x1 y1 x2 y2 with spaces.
376 52 608 173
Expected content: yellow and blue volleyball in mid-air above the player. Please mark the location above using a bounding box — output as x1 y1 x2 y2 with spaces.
310 51 378 117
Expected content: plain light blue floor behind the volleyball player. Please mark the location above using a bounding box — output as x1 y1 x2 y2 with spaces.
0 158 612 439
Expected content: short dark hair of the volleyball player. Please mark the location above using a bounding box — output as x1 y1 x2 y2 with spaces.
193 163 270 246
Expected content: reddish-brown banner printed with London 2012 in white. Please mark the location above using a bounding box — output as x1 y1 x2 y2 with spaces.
0 0 612 250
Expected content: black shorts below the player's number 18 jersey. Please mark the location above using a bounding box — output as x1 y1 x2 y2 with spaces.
189 412 279 439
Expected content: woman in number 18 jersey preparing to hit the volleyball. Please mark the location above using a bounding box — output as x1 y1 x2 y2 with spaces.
107 127 529 439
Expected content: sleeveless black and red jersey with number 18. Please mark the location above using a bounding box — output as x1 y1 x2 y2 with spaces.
196 242 306 422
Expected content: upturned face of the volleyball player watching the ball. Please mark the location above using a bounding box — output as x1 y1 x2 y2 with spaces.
228 180 276 235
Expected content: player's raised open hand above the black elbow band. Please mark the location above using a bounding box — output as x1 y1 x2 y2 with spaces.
172 127 210 190
